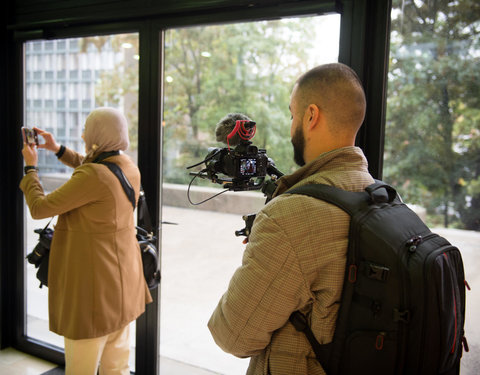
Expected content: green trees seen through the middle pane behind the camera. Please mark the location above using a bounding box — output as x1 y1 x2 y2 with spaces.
164 18 321 183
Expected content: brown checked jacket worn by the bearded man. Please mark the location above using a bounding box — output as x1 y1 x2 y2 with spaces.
208 147 374 375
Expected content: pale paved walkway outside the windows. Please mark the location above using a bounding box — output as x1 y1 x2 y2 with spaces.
27 206 480 375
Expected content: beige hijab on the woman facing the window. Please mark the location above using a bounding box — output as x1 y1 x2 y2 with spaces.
83 107 129 163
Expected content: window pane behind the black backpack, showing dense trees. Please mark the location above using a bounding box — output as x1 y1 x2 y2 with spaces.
384 0 480 374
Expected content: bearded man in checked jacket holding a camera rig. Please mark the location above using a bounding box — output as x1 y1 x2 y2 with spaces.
209 64 374 375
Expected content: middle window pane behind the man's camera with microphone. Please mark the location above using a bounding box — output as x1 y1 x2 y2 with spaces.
160 15 340 374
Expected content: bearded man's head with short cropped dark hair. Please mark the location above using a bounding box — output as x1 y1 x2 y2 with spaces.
290 63 366 165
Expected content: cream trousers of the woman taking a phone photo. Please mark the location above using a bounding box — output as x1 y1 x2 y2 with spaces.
65 325 130 375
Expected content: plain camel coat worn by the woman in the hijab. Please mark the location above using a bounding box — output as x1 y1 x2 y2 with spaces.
20 148 152 340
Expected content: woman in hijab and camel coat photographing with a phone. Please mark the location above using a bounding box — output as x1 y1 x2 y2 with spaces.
20 108 152 375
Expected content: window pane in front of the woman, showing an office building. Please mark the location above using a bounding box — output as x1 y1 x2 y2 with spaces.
24 34 138 369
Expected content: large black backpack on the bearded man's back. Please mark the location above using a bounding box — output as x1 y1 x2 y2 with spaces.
287 181 468 375
